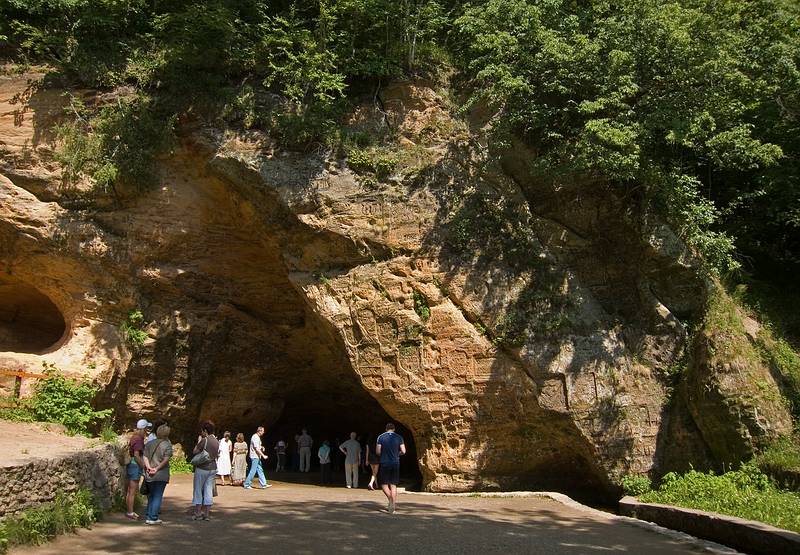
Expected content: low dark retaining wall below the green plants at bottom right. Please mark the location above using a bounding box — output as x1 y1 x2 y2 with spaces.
619 497 800 555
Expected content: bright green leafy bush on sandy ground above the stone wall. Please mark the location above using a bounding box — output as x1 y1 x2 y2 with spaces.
29 364 112 435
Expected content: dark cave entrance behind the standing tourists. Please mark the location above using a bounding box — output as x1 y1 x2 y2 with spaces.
264 378 422 489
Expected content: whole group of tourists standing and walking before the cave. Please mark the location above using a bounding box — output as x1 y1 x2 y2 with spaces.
124 418 406 525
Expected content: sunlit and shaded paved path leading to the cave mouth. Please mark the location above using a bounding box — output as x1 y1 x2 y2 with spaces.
12 476 724 555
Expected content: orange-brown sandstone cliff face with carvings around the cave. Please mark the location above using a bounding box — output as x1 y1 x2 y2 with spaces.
0 76 785 491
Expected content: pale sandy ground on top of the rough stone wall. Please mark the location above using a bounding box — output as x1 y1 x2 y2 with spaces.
0 420 95 468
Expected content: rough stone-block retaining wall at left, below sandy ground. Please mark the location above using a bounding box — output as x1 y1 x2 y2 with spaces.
0 444 125 518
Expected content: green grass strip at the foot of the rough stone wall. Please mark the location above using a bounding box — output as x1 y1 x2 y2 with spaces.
0 489 102 553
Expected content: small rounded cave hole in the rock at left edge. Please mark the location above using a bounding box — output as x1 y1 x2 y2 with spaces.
0 276 67 353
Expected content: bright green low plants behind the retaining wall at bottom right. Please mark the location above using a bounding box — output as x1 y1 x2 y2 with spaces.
639 464 800 532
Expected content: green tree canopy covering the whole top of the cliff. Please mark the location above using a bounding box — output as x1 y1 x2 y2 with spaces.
0 0 800 278
